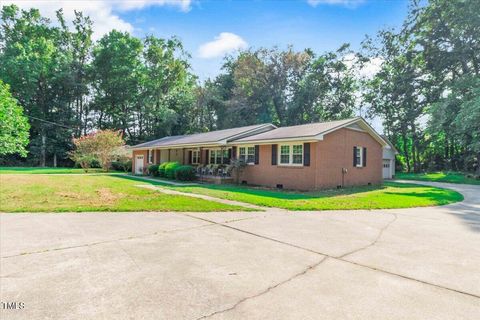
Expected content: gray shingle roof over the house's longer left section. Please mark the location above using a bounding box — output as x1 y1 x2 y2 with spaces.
132 123 275 149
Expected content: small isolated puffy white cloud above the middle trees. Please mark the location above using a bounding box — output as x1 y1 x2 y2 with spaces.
198 32 248 59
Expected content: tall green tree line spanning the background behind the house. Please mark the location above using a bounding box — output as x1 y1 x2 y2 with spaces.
0 0 480 173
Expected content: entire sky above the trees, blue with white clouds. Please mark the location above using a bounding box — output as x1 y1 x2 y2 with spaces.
0 0 408 81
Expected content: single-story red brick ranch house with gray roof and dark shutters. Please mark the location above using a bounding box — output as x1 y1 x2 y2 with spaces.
131 117 389 190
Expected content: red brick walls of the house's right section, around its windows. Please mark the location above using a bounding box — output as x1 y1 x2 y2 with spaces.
240 129 382 190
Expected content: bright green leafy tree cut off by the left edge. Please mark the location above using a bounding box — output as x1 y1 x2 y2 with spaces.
0 80 30 157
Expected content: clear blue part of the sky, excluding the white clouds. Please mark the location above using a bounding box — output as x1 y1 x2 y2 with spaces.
125 0 408 79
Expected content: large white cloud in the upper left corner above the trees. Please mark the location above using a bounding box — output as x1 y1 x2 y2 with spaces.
1 0 191 39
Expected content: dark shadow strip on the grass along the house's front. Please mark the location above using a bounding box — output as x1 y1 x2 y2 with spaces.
116 175 394 200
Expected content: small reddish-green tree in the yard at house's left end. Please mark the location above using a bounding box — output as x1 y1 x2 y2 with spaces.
70 130 125 172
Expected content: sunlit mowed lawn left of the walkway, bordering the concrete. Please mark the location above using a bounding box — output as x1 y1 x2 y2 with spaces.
0 174 248 212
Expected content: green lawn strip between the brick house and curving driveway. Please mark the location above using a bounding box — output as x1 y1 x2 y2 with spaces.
124 177 463 210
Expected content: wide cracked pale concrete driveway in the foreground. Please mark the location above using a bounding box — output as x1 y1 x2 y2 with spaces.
0 184 480 320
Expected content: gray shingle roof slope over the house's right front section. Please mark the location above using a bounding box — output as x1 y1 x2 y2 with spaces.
235 118 360 142
